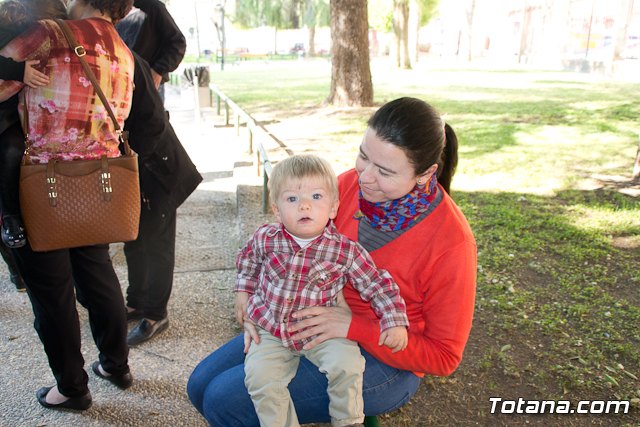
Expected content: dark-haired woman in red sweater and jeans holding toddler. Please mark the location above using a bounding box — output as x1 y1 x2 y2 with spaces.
187 98 477 426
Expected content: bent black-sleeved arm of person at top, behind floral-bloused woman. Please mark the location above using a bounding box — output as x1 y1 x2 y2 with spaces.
135 0 187 76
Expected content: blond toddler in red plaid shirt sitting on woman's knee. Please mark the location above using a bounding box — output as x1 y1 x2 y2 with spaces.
235 156 409 427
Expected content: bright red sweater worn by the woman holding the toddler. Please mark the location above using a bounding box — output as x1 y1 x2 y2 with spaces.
335 172 477 375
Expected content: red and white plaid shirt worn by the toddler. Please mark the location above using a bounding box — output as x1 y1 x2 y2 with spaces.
235 222 409 350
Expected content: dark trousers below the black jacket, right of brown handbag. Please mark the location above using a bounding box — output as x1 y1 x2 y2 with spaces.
124 184 176 320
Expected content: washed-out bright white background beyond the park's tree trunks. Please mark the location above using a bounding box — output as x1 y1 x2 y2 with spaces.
166 0 640 75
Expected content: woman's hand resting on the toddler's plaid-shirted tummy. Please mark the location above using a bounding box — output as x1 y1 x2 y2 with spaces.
291 292 351 350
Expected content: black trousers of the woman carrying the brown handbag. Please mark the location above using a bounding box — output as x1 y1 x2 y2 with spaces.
14 244 129 397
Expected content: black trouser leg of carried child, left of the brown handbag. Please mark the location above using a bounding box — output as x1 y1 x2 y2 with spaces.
0 122 24 215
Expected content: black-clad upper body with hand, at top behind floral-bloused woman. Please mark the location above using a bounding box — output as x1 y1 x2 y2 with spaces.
116 0 187 102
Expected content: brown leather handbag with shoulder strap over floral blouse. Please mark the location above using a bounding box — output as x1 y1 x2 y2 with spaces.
20 20 140 252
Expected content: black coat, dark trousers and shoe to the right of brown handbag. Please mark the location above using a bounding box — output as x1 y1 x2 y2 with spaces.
124 52 202 346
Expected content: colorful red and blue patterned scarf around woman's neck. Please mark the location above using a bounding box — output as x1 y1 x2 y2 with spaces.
354 173 438 231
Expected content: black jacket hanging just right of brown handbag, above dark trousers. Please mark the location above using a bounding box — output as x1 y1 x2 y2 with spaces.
124 52 202 209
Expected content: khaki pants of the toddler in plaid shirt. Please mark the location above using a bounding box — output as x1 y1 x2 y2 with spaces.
244 329 364 427
